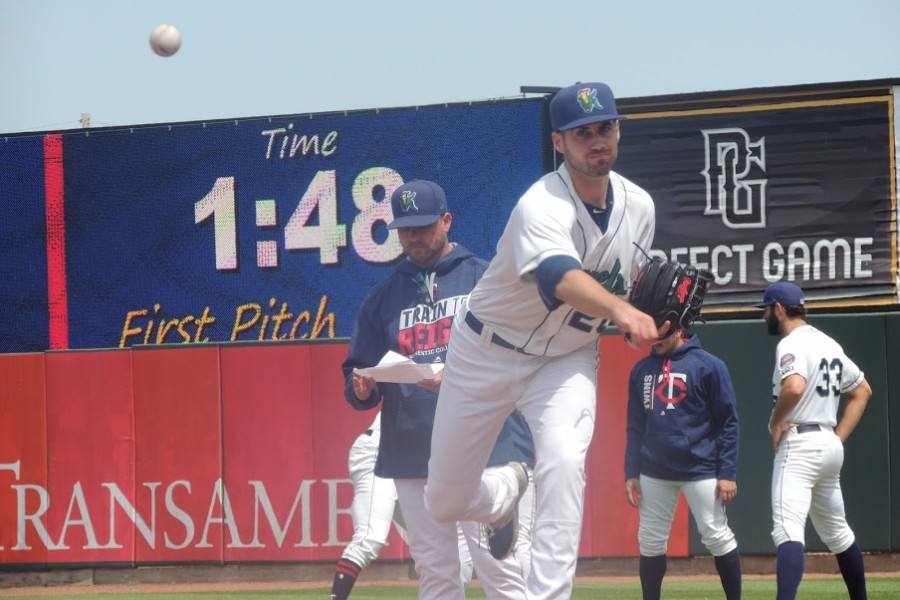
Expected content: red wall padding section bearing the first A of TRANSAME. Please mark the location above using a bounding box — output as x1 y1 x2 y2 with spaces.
45 350 134 563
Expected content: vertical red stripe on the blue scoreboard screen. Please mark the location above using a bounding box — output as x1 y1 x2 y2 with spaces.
44 133 69 350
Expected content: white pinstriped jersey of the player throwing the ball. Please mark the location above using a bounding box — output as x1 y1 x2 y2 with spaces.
469 165 656 356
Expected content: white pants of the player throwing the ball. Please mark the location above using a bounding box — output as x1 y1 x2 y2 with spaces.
426 311 598 599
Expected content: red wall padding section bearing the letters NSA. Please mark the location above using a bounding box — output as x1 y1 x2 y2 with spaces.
131 346 224 563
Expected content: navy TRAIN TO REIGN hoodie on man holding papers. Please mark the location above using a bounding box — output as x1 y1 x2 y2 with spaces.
341 244 534 479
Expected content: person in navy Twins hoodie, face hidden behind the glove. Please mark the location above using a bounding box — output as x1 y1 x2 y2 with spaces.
625 328 741 600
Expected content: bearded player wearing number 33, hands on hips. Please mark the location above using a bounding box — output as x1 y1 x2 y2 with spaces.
756 281 872 600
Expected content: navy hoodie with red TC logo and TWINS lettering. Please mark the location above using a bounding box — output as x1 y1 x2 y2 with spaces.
625 335 739 481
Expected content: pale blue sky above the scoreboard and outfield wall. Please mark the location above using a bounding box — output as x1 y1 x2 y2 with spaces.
0 0 900 133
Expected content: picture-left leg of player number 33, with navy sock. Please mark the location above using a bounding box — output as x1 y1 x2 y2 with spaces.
772 430 820 600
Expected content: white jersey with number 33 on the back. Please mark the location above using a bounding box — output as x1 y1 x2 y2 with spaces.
772 325 863 427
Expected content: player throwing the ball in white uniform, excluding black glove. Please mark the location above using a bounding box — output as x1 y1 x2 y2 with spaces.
426 83 669 599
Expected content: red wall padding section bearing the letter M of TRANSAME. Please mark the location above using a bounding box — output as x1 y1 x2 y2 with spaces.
221 345 324 561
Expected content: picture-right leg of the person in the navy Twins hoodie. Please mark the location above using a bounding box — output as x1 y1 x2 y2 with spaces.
683 479 741 600
